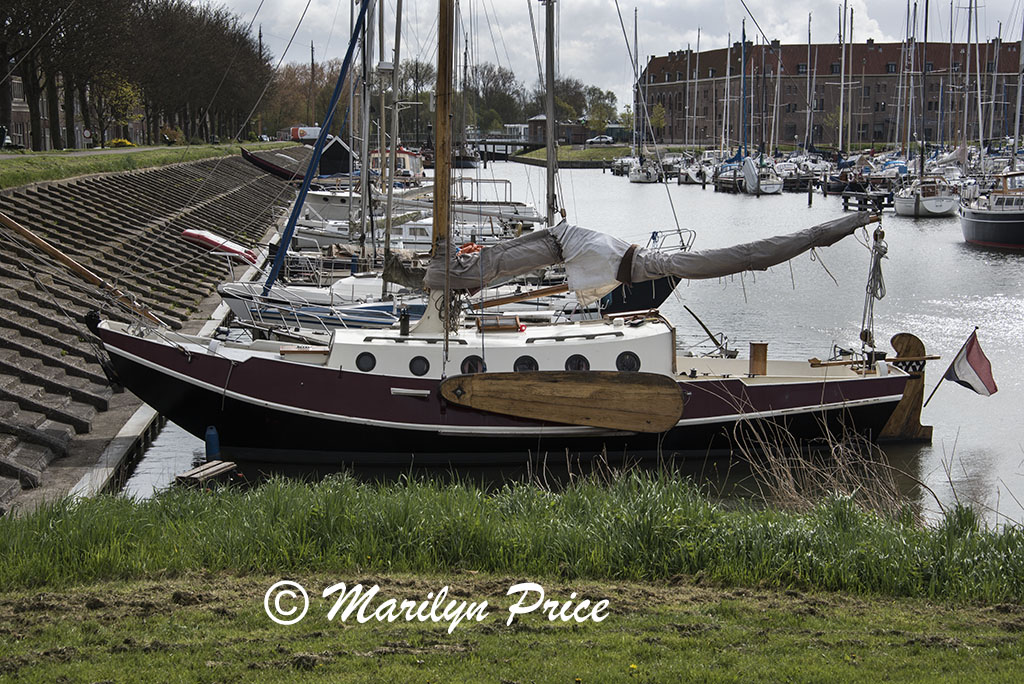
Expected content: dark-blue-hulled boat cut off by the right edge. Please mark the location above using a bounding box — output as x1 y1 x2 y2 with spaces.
959 171 1024 250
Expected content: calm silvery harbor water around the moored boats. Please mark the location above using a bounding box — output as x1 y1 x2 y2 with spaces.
127 163 1024 521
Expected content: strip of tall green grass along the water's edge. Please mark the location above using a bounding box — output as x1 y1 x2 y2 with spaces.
0 473 1024 603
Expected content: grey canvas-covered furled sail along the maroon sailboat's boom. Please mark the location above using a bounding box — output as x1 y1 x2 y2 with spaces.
423 212 871 302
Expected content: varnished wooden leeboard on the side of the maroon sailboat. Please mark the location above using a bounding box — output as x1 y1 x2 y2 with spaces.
441 371 683 432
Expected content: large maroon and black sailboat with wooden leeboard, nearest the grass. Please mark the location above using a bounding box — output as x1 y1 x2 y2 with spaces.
93 0 909 465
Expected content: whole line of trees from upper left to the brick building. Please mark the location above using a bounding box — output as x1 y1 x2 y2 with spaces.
0 0 628 149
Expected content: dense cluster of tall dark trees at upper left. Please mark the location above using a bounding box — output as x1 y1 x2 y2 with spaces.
0 0 272 149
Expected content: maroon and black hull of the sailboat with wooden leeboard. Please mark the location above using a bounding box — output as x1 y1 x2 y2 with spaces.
101 331 905 466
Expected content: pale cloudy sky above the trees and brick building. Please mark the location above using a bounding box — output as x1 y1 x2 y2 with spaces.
225 0 1024 106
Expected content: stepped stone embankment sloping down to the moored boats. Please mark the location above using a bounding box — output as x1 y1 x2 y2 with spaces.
0 152 294 513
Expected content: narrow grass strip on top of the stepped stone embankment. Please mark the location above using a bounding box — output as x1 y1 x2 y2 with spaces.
0 142 294 189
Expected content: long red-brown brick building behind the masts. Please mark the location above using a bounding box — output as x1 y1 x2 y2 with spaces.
636 39 1020 147
